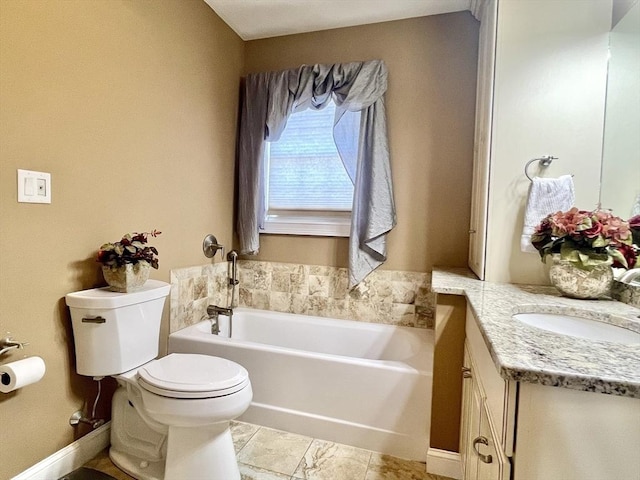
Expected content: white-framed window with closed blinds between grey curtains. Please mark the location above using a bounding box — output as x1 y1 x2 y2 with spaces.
262 102 353 237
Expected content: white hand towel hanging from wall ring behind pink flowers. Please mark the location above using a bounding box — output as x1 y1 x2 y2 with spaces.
520 175 575 253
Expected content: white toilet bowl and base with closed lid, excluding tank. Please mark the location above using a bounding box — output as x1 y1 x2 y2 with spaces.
109 353 253 480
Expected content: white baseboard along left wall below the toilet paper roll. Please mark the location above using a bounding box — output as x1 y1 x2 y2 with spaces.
11 422 111 480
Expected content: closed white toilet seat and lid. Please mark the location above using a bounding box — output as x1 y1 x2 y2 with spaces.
138 353 249 399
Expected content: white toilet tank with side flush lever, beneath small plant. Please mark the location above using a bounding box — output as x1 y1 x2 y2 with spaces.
65 280 171 377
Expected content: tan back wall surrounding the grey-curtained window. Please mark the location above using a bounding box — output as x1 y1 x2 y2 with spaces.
245 12 478 272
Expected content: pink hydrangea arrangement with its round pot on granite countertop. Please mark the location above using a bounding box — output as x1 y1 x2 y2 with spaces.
531 207 637 298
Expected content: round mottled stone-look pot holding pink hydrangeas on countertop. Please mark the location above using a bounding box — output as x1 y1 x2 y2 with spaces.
549 258 613 299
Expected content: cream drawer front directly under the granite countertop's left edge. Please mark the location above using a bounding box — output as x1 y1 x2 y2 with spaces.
466 307 516 456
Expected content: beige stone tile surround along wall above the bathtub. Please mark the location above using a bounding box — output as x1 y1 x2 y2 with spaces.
170 260 435 332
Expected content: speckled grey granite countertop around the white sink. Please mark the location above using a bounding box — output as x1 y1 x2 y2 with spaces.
432 268 640 398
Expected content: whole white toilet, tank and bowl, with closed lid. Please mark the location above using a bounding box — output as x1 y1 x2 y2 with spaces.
65 280 253 480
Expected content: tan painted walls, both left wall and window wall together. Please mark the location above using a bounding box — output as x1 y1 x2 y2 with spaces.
0 4 478 478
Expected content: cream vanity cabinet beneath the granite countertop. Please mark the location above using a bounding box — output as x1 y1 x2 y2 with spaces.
460 308 640 480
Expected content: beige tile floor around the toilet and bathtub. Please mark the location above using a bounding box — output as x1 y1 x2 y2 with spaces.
85 422 451 480
